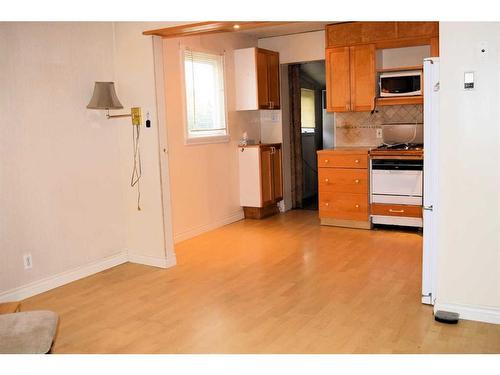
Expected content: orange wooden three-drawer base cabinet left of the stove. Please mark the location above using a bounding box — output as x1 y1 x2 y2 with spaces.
318 148 371 229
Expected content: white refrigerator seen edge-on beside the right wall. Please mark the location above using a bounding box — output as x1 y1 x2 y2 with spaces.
422 57 439 305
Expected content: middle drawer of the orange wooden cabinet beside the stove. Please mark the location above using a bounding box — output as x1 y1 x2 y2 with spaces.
318 168 368 194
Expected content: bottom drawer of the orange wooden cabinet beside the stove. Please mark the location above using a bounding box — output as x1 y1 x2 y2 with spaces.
319 192 368 221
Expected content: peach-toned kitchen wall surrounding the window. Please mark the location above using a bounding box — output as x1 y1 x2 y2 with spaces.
163 33 260 242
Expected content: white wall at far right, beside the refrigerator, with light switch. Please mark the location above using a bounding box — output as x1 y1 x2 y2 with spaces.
437 22 500 323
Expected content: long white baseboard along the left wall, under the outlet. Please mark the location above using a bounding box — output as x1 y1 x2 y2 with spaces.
0 251 128 302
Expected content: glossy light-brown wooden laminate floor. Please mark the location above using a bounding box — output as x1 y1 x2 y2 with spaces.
23 211 500 353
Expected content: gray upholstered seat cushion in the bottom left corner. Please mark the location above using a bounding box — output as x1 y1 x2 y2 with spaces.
0 311 58 354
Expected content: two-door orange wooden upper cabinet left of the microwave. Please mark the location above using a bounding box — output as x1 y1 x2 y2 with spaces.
326 44 376 112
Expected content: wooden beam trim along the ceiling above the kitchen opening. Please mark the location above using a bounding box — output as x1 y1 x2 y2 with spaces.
142 21 295 38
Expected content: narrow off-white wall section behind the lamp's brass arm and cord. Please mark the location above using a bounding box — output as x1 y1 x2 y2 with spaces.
113 22 180 263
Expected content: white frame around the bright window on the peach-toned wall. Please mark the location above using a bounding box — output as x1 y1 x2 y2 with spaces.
179 46 231 146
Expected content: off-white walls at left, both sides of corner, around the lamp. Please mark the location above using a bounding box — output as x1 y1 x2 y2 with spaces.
0 22 180 300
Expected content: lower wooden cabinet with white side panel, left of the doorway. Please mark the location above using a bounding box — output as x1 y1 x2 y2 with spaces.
239 143 283 219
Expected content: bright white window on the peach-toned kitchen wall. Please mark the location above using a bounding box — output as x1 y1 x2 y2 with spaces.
184 49 228 143
